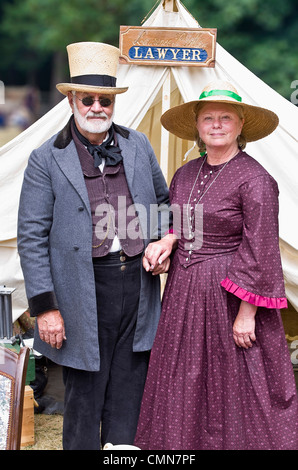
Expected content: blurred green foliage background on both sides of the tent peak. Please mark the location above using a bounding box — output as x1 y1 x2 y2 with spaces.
0 0 298 98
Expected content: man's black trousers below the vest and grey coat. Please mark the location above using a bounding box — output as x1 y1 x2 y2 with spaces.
63 252 150 450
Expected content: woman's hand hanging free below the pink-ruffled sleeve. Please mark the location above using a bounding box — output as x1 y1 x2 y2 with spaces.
233 300 257 349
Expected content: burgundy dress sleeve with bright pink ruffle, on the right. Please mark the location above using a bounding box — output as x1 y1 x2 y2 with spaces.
221 175 287 309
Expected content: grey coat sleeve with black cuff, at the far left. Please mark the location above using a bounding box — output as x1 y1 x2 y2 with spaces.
18 144 58 316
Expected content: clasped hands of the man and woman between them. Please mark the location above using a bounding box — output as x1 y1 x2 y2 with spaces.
143 234 177 275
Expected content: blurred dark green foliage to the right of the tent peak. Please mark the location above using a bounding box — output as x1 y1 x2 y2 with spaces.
184 0 298 99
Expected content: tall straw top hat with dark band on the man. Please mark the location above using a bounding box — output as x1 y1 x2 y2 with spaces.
56 42 128 95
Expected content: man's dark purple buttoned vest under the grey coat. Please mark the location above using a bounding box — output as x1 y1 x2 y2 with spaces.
72 123 144 257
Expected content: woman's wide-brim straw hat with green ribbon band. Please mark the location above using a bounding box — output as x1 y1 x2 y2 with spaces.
161 80 279 142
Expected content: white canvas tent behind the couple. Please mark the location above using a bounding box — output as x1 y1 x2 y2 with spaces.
0 0 298 320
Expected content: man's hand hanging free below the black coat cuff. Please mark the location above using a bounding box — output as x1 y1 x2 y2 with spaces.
37 310 66 349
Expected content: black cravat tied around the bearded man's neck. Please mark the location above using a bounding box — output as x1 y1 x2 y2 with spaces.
74 121 122 168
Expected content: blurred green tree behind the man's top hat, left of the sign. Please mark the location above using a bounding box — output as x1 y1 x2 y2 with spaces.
0 0 151 103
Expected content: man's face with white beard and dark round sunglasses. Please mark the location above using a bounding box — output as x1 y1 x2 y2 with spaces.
68 92 115 140
